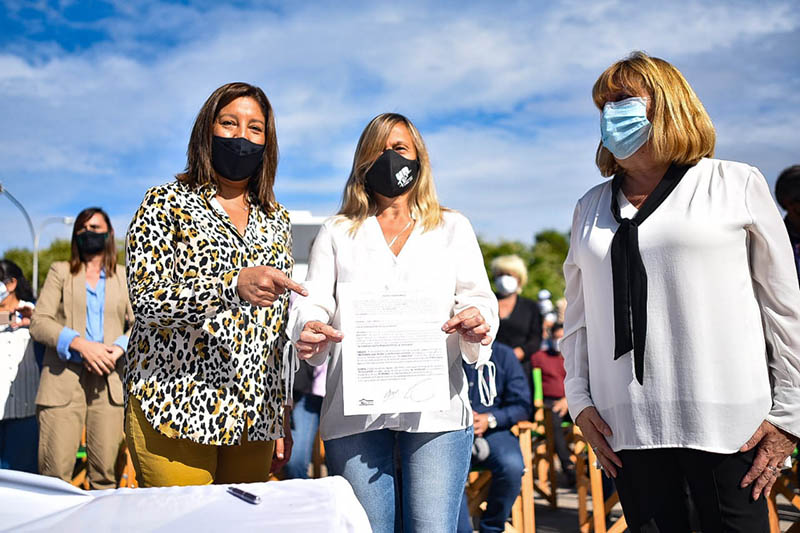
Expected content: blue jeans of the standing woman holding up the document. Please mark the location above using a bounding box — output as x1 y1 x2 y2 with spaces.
325 426 472 533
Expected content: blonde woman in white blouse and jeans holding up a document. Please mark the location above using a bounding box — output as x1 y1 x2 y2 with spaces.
289 113 498 533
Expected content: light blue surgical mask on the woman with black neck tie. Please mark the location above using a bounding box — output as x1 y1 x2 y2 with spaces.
600 96 653 159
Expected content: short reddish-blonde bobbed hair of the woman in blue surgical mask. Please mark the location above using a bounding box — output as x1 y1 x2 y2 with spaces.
592 52 716 176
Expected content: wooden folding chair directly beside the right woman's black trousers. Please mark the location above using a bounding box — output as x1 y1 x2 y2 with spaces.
573 425 628 533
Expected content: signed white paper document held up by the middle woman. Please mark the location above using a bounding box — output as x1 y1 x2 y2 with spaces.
336 283 450 415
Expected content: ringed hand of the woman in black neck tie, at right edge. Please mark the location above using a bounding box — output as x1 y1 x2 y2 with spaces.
739 420 797 500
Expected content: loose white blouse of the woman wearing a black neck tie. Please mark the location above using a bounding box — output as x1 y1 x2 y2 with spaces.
561 159 800 453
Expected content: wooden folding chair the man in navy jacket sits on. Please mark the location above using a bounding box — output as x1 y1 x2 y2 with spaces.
466 421 536 533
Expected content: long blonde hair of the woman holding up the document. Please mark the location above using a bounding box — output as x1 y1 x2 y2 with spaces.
338 113 445 235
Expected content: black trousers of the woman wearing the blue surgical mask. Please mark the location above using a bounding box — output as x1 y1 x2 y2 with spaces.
614 448 769 533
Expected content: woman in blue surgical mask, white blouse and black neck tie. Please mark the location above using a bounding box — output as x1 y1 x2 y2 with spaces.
561 52 800 532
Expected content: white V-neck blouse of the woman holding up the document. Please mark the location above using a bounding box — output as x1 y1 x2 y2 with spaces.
288 211 498 439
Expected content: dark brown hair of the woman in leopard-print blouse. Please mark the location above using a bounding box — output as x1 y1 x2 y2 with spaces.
176 82 278 213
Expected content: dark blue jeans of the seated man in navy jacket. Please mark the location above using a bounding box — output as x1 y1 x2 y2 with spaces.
458 430 525 533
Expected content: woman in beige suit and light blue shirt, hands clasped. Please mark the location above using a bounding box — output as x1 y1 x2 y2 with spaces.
31 207 133 489
